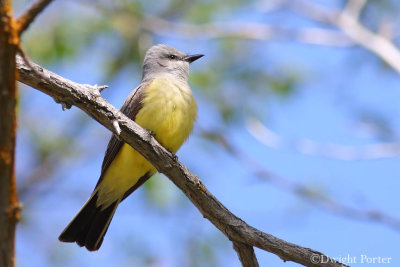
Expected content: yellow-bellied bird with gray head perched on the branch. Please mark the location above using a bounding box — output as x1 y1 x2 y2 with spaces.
59 44 204 251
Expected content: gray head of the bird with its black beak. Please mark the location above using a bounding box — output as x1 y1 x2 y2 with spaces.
142 44 203 81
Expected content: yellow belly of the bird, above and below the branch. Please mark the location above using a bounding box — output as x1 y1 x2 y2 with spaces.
98 79 197 206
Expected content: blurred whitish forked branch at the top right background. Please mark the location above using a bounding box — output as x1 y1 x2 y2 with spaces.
104 0 400 74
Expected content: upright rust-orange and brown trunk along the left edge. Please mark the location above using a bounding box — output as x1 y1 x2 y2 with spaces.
0 0 19 267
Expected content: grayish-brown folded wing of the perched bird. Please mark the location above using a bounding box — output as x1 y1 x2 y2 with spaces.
96 81 151 187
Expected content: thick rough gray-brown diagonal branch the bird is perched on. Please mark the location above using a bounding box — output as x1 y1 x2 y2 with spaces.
17 57 344 267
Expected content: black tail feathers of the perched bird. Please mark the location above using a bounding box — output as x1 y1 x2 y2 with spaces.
58 192 120 251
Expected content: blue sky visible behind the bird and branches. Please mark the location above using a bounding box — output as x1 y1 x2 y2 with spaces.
13 3 400 266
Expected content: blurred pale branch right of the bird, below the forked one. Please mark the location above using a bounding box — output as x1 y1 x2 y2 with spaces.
246 118 400 160
